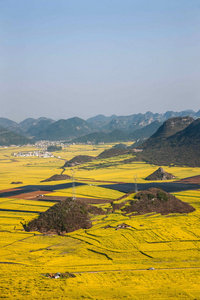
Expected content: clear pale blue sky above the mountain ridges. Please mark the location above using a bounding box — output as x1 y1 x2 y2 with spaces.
0 0 200 122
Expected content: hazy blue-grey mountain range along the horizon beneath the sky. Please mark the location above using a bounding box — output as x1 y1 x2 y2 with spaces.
0 110 200 144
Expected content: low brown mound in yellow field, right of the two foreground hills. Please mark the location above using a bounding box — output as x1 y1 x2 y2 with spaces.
123 188 195 215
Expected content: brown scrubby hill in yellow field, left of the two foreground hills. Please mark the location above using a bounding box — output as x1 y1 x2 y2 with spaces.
23 198 104 234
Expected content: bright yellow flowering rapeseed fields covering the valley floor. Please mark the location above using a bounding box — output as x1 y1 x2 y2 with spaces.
0 145 200 300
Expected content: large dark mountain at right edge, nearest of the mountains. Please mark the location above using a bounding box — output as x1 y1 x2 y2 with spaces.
138 117 200 167
